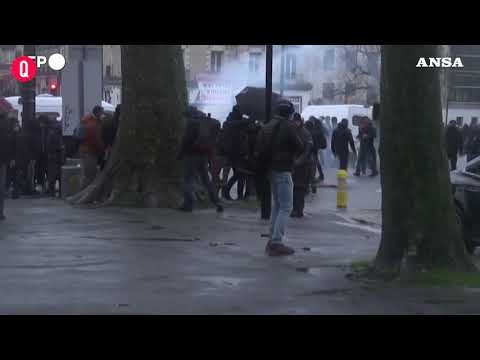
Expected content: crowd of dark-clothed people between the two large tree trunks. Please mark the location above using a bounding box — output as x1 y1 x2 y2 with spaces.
178 100 378 256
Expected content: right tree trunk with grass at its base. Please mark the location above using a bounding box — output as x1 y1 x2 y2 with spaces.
375 45 472 272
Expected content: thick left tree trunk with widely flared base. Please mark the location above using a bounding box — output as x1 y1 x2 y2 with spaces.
70 45 188 207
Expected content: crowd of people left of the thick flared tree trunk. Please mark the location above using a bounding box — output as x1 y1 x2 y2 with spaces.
0 102 120 220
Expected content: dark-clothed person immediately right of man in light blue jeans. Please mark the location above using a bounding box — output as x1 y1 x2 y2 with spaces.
290 113 318 218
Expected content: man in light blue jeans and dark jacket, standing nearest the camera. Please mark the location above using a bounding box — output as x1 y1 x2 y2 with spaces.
257 100 303 256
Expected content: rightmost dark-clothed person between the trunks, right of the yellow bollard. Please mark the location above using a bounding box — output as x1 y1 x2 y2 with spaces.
354 117 378 177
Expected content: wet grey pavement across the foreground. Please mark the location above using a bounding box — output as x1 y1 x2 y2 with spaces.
0 167 480 314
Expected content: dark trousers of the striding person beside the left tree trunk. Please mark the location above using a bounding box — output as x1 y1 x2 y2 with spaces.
183 155 218 208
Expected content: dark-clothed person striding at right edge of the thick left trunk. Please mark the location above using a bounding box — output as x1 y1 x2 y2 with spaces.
177 107 224 212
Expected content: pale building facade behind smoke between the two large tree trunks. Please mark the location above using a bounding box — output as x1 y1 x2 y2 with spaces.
182 45 380 118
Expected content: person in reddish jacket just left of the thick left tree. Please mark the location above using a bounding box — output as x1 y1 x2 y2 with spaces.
79 105 105 190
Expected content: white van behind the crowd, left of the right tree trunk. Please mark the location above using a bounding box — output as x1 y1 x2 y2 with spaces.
302 104 373 137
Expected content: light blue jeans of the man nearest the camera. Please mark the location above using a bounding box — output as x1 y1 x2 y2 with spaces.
270 171 293 242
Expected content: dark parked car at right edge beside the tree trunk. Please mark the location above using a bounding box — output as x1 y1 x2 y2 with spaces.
450 156 480 253
